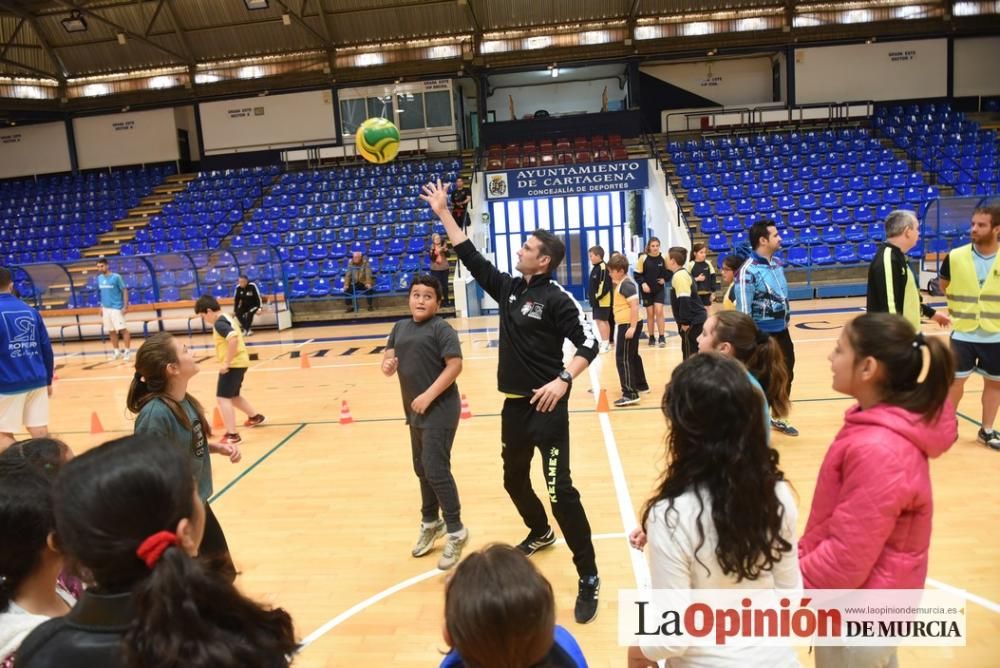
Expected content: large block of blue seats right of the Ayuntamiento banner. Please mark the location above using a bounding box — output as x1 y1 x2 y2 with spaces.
667 128 938 267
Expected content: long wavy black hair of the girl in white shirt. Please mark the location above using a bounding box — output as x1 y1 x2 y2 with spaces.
642 353 792 581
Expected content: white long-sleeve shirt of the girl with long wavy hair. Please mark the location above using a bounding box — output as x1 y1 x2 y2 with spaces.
641 482 802 668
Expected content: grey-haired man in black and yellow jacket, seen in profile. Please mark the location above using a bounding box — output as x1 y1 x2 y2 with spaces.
868 210 951 330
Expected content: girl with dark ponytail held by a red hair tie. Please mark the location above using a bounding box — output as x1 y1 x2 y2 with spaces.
17 436 296 668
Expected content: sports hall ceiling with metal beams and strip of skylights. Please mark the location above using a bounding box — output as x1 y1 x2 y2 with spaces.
0 0 1000 109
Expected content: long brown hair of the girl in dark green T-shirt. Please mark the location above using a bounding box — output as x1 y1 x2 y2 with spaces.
125 332 212 437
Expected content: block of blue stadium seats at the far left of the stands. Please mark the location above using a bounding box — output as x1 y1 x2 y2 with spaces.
0 165 175 266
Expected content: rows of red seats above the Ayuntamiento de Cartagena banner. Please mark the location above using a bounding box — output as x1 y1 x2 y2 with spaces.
486 135 629 169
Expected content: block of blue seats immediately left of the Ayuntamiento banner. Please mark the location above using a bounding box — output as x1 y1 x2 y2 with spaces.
231 159 462 299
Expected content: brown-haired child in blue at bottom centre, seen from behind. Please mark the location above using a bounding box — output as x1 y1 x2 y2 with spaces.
441 545 587 668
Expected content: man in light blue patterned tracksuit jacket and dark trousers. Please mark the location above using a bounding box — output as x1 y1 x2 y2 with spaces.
733 220 799 436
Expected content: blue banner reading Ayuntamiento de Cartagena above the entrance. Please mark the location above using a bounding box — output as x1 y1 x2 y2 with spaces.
486 160 649 199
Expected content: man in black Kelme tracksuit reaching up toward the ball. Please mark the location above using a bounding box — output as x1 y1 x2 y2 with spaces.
421 181 600 624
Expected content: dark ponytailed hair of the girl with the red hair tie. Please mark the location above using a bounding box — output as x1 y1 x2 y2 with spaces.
55 436 296 668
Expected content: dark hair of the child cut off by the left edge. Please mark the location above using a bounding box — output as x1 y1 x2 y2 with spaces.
0 458 56 612
